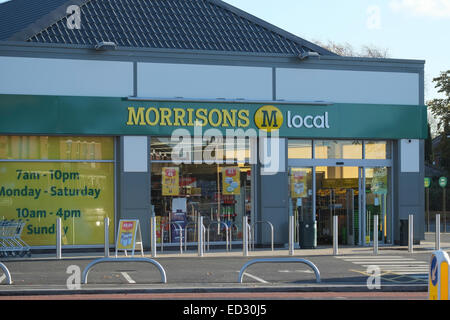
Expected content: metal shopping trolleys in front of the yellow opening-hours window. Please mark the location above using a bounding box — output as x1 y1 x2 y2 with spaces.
0 220 31 257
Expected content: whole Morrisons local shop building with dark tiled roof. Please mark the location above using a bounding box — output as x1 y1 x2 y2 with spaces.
0 0 427 248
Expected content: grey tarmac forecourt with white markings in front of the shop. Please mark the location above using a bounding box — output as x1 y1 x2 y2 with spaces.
0 233 450 297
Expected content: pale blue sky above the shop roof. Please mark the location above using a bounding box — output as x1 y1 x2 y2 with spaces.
0 0 450 100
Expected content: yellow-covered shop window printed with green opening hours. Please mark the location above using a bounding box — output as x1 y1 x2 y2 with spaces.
0 136 114 246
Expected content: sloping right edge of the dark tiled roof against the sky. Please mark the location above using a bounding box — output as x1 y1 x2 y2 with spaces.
206 0 339 56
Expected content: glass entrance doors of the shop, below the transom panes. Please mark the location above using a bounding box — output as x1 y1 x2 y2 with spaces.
289 166 392 248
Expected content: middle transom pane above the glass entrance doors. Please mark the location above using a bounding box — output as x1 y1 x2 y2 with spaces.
314 140 362 159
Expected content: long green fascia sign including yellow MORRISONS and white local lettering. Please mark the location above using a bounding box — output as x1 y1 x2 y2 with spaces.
0 95 427 139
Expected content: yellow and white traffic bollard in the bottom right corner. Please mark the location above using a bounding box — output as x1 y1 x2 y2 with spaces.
428 250 450 300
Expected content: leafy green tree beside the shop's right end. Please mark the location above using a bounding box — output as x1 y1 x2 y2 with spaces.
427 70 450 173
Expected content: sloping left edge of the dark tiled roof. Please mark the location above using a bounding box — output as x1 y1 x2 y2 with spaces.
7 0 91 41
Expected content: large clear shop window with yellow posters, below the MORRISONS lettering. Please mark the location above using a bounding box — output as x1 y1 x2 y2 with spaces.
150 137 252 244
